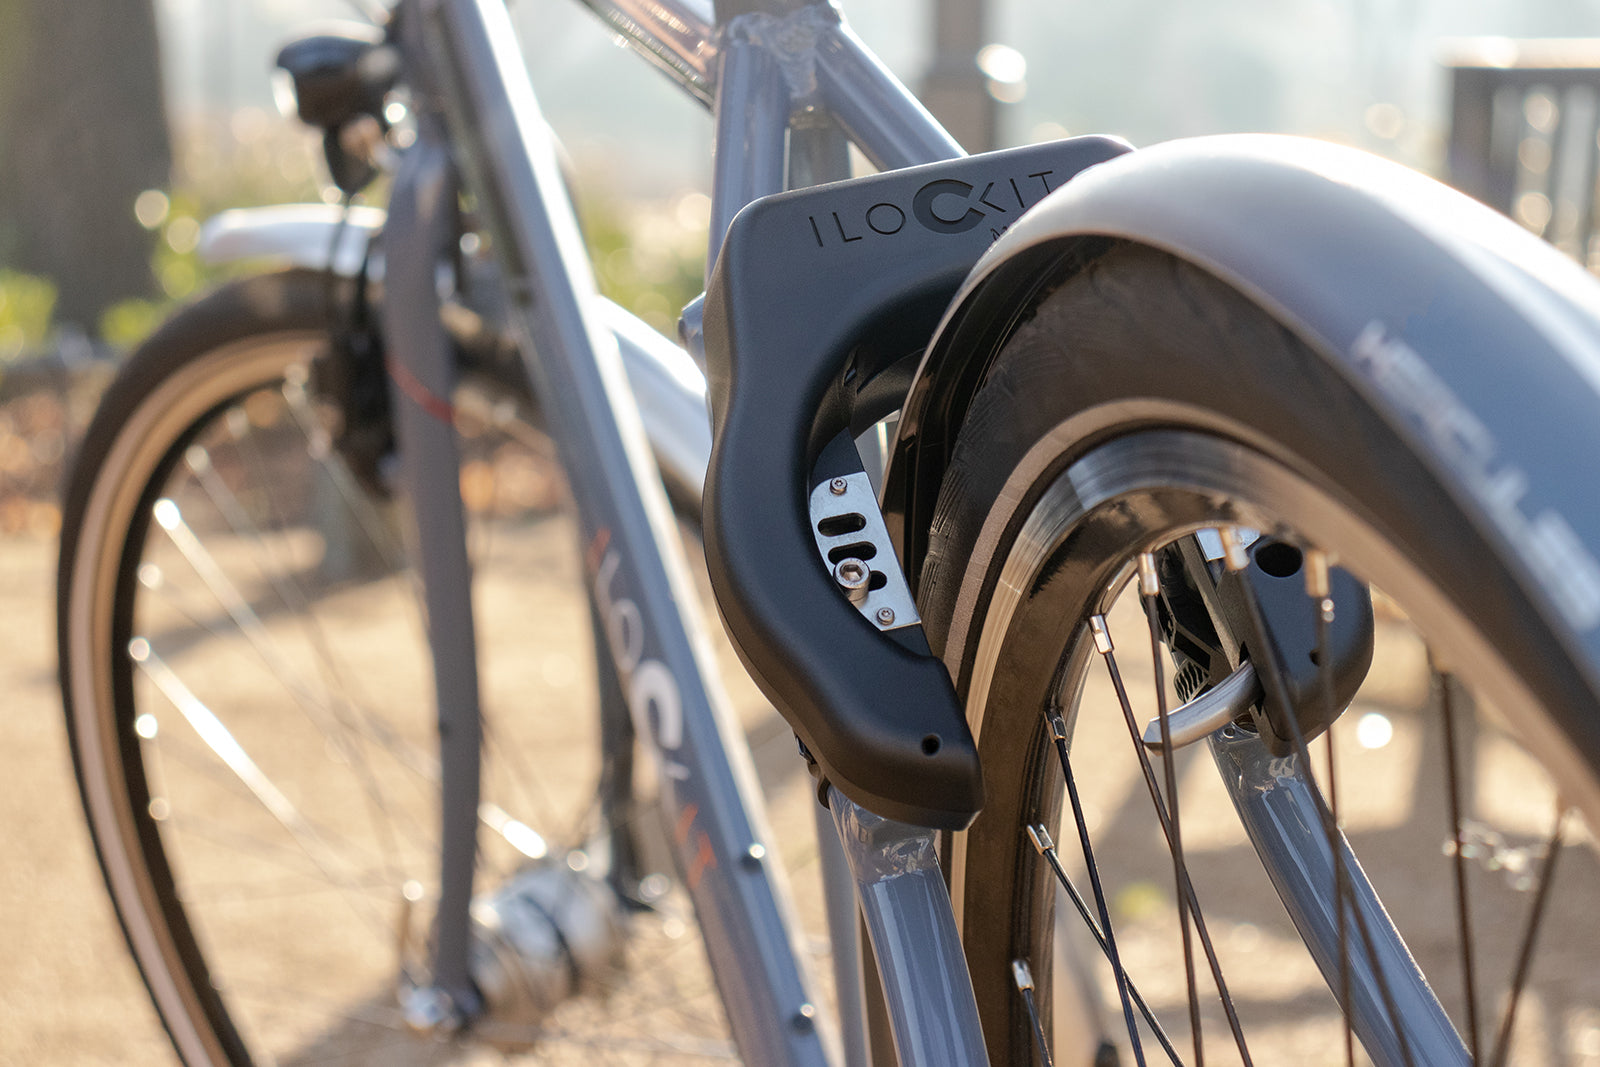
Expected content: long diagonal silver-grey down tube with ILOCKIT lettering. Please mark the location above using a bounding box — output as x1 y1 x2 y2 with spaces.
390 0 960 1064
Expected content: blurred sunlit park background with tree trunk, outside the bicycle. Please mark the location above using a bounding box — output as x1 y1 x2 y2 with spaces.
0 0 1600 1065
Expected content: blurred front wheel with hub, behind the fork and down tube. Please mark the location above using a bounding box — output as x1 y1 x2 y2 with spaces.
59 272 806 1064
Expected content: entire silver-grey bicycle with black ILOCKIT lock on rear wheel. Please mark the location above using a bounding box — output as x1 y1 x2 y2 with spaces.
50 0 1600 1064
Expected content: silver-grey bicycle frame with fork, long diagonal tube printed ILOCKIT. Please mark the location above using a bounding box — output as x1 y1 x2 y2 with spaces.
384 0 982 1065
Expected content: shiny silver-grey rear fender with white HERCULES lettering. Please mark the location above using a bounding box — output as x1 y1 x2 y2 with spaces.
885 136 1600 800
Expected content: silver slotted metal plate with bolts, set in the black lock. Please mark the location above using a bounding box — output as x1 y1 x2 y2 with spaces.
811 474 922 630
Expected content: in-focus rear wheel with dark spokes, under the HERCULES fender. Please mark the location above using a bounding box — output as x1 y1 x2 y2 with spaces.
920 246 1600 1064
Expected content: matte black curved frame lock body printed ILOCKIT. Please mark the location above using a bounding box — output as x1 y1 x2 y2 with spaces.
704 138 1128 829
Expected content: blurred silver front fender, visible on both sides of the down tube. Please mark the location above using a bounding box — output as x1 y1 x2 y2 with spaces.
198 203 710 501
